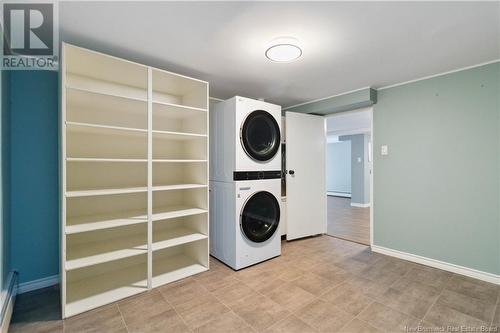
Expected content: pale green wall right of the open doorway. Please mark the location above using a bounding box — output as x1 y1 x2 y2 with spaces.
373 63 500 274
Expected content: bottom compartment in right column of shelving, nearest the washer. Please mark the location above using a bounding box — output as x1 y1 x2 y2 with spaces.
153 255 208 288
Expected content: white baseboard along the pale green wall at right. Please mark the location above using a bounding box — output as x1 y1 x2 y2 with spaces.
371 245 500 285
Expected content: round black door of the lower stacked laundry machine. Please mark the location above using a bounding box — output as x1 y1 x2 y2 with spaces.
240 191 280 243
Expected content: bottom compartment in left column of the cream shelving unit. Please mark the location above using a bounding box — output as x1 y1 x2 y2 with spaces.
65 263 148 317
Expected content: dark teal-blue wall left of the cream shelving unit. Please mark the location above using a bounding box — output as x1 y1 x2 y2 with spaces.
10 71 59 283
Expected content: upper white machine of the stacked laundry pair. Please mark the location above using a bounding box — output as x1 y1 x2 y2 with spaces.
210 96 281 182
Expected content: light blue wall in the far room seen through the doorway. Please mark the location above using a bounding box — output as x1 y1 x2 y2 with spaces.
326 141 351 194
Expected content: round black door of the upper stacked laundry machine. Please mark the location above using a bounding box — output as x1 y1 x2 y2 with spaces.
240 110 281 162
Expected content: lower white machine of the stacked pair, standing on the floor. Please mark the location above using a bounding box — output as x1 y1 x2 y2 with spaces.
210 179 281 270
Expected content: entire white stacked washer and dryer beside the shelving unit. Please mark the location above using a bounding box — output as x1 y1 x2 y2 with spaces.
210 96 281 270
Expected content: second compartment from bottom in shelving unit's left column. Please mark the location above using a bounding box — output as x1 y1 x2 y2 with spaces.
65 235 148 271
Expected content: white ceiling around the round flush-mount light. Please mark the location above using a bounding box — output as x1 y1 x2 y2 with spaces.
59 1 500 107
